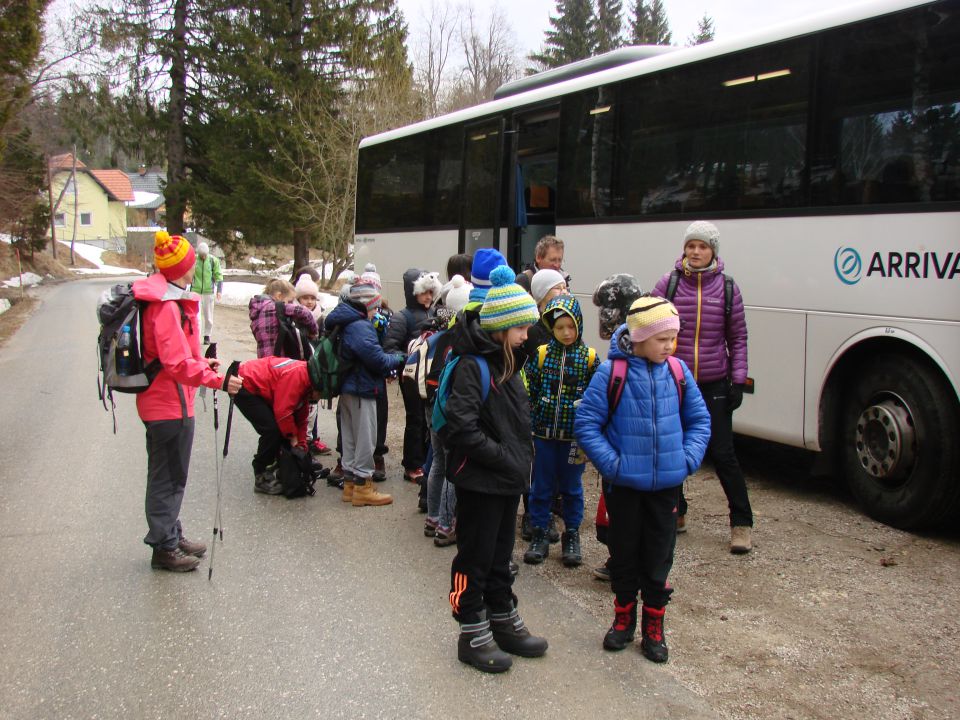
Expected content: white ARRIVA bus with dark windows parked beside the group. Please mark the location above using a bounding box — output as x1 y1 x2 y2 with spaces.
355 0 960 528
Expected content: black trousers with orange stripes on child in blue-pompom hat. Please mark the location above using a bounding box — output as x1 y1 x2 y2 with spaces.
450 487 520 623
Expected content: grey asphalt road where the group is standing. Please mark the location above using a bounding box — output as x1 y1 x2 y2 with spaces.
0 280 715 718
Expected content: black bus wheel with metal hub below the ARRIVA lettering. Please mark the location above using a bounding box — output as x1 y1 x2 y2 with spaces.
841 354 960 529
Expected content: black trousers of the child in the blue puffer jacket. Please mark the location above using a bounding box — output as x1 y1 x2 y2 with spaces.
608 484 680 608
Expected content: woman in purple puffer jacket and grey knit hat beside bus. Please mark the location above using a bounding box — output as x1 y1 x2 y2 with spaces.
652 220 753 554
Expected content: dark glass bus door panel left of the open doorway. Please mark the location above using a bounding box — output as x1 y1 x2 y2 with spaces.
460 118 507 255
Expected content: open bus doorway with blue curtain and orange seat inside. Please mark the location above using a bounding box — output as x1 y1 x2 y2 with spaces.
504 107 560 271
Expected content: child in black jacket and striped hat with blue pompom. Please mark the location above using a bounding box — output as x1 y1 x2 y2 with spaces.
438 266 547 672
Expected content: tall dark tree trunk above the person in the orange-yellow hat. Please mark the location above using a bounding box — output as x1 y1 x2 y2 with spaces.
163 0 188 235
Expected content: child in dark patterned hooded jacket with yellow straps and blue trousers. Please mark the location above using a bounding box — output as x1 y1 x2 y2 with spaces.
523 295 600 567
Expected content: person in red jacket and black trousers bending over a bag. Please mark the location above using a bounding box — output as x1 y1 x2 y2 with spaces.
235 357 320 495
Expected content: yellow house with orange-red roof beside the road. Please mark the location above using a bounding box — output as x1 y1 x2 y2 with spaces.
50 153 134 252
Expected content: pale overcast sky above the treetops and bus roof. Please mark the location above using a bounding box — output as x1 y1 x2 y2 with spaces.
398 0 858 55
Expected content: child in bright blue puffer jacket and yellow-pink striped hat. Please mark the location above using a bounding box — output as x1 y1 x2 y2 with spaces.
574 297 710 662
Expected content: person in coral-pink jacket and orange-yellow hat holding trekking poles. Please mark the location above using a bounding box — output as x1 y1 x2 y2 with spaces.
133 231 240 572
